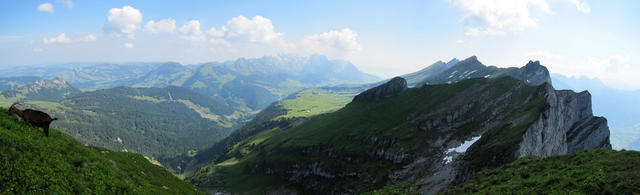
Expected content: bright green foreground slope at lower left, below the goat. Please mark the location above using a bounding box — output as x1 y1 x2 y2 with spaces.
0 108 199 194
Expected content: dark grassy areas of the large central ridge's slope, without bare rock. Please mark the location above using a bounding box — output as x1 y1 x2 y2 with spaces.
192 78 539 192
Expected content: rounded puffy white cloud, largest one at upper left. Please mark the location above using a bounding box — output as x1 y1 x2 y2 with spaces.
103 5 142 39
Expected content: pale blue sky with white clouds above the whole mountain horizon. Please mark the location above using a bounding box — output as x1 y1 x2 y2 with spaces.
0 0 640 90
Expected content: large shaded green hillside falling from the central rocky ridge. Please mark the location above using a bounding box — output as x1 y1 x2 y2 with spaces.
185 78 543 193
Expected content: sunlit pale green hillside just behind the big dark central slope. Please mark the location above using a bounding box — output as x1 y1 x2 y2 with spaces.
159 86 366 176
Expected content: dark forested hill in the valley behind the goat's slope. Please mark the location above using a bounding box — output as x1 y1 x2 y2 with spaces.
20 87 245 161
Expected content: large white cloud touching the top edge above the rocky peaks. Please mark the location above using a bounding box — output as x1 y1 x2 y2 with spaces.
451 0 551 36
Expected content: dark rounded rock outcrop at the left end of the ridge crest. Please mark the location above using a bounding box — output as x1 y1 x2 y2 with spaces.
353 77 407 102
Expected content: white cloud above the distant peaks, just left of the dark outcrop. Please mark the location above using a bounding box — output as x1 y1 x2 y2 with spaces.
300 28 361 58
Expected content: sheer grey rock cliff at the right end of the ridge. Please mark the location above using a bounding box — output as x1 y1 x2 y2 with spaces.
517 84 611 157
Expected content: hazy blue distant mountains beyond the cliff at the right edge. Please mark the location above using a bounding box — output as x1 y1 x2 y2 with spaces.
551 74 640 150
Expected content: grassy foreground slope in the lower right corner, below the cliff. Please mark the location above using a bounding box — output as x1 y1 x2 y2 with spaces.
443 149 640 194
